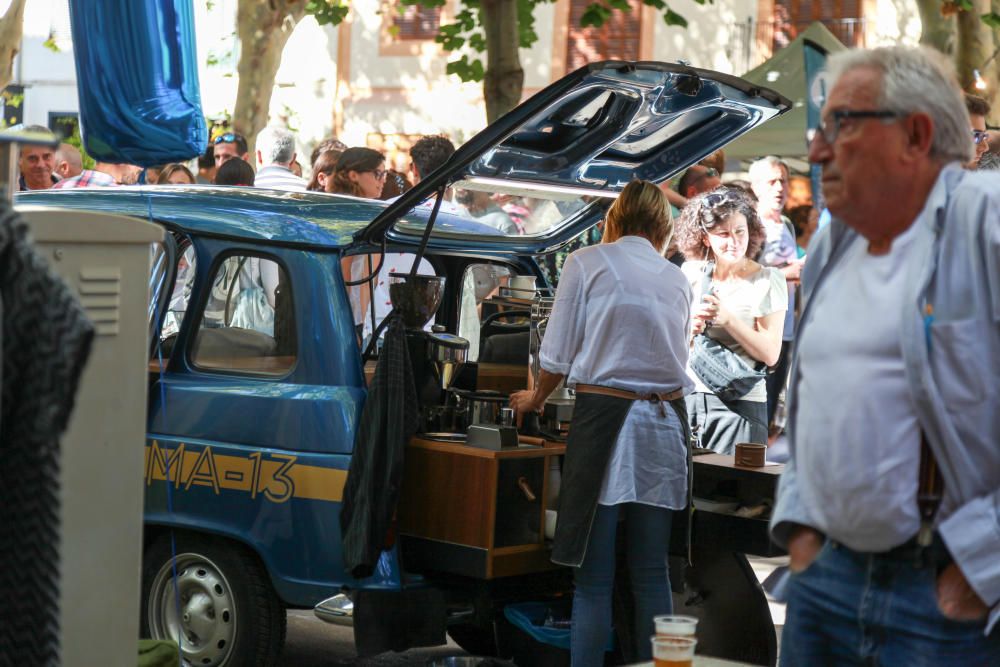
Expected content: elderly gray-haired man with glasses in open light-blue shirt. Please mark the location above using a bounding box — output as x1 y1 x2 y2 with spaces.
771 47 1000 666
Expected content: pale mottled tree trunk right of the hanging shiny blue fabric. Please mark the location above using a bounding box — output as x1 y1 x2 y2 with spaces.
233 0 306 156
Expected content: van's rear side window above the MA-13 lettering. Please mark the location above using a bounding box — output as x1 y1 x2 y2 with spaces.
192 255 297 375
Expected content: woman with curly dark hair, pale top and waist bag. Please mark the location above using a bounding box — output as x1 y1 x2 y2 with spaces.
677 187 788 454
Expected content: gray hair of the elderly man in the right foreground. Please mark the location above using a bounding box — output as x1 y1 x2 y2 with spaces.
826 46 975 162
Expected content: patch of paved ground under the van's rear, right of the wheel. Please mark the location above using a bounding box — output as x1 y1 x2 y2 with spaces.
278 611 466 667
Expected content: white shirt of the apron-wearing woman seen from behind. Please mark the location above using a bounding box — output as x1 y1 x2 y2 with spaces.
539 236 693 509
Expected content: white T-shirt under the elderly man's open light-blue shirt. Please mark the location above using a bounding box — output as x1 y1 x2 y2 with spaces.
794 225 920 551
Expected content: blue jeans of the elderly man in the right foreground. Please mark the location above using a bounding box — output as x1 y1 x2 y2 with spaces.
780 541 1000 667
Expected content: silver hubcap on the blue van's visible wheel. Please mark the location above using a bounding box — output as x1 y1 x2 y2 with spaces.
147 553 236 667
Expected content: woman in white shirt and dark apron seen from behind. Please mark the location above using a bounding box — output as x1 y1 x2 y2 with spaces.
510 181 693 667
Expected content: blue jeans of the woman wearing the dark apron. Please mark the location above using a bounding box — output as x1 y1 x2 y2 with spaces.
570 503 673 667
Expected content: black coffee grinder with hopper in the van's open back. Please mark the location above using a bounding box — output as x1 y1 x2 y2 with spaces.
389 273 469 433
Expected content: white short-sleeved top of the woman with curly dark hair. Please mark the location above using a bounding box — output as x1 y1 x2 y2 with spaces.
681 261 788 403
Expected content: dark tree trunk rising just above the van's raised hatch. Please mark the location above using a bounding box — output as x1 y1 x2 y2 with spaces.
479 0 524 123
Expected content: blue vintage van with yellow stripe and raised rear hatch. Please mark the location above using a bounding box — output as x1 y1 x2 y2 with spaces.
18 62 789 667
